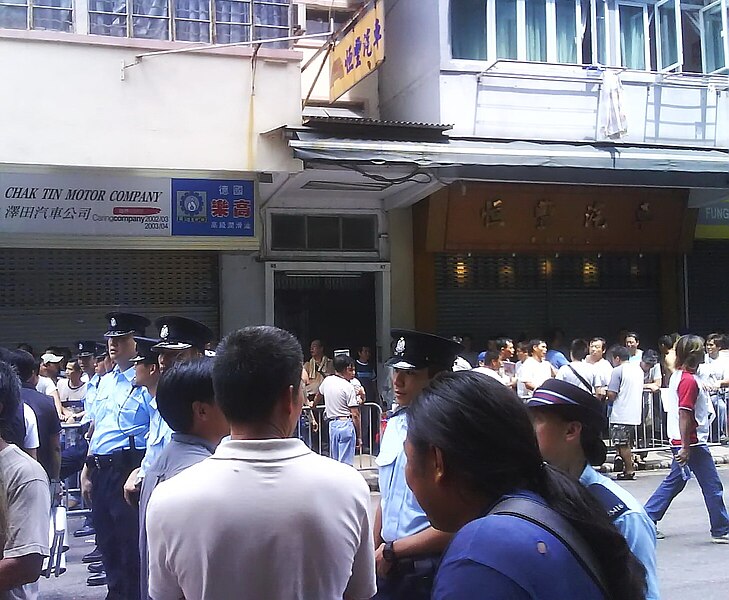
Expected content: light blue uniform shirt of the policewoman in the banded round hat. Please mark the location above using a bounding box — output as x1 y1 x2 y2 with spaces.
580 465 661 600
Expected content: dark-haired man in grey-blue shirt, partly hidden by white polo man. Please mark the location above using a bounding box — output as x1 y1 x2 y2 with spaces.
138 358 230 600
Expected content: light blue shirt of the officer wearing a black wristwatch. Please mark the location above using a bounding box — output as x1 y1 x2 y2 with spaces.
376 410 430 542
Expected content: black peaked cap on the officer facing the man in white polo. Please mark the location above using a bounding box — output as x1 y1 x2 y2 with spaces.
386 329 463 370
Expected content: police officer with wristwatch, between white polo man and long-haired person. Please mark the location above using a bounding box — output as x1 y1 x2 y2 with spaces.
374 329 462 600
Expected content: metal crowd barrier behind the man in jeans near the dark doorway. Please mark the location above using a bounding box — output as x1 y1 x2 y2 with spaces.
296 402 383 471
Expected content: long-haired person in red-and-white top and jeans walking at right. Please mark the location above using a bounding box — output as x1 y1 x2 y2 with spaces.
645 335 729 544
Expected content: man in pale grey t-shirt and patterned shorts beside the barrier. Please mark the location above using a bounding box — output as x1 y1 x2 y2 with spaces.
607 346 643 479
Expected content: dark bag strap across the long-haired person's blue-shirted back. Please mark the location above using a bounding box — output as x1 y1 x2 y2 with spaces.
488 497 610 598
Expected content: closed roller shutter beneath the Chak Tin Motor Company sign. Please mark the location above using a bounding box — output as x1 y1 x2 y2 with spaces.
0 249 219 352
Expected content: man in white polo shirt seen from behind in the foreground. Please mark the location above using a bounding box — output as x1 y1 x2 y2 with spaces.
147 326 376 600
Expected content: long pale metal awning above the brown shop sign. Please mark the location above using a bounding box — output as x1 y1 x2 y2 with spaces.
289 134 729 189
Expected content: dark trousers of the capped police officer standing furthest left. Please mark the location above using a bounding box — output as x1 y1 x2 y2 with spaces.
91 465 139 600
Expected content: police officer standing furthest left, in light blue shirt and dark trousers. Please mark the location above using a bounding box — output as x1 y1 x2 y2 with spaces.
81 312 152 600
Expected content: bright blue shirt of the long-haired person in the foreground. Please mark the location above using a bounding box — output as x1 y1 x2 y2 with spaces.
432 491 604 600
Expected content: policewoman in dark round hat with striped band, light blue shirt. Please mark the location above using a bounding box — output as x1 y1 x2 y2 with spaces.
527 379 660 600
